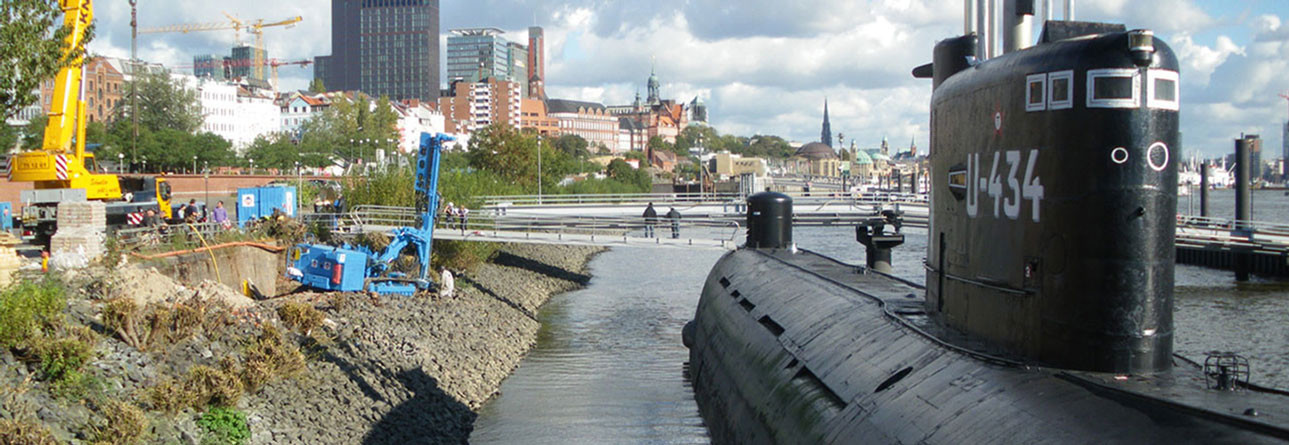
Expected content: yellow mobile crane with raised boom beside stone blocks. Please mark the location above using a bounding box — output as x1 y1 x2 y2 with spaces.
9 0 171 244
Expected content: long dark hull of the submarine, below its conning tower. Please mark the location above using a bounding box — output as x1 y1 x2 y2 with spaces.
687 249 1285 444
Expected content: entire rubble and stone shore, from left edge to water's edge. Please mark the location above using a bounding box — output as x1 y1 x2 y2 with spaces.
0 245 601 445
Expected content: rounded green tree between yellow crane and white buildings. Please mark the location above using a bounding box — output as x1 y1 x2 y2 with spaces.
115 71 205 134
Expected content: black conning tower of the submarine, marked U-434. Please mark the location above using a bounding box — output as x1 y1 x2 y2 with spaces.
914 22 1179 374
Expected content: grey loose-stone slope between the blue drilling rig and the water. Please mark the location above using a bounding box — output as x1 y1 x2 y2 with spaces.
244 245 599 444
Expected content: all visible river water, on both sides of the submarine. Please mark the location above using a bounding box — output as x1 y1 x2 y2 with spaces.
470 191 1289 444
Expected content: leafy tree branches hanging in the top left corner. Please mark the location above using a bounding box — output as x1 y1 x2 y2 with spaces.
0 0 94 119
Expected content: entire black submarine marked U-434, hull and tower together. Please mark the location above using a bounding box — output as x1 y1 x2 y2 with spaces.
682 0 1289 444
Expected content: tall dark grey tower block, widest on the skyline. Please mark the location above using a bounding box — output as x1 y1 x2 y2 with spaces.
313 0 440 101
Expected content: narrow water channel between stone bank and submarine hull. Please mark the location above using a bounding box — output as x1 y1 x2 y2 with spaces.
470 249 721 444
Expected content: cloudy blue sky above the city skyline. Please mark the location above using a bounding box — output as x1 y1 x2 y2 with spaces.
90 0 1289 159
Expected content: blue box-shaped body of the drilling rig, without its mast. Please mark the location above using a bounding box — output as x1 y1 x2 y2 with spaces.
286 244 367 292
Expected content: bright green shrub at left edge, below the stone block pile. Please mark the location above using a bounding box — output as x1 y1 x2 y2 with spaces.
0 277 67 348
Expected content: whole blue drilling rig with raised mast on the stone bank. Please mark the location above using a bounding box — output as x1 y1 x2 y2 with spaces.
286 133 454 295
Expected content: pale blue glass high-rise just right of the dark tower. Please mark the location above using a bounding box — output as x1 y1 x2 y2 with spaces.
447 28 528 92
